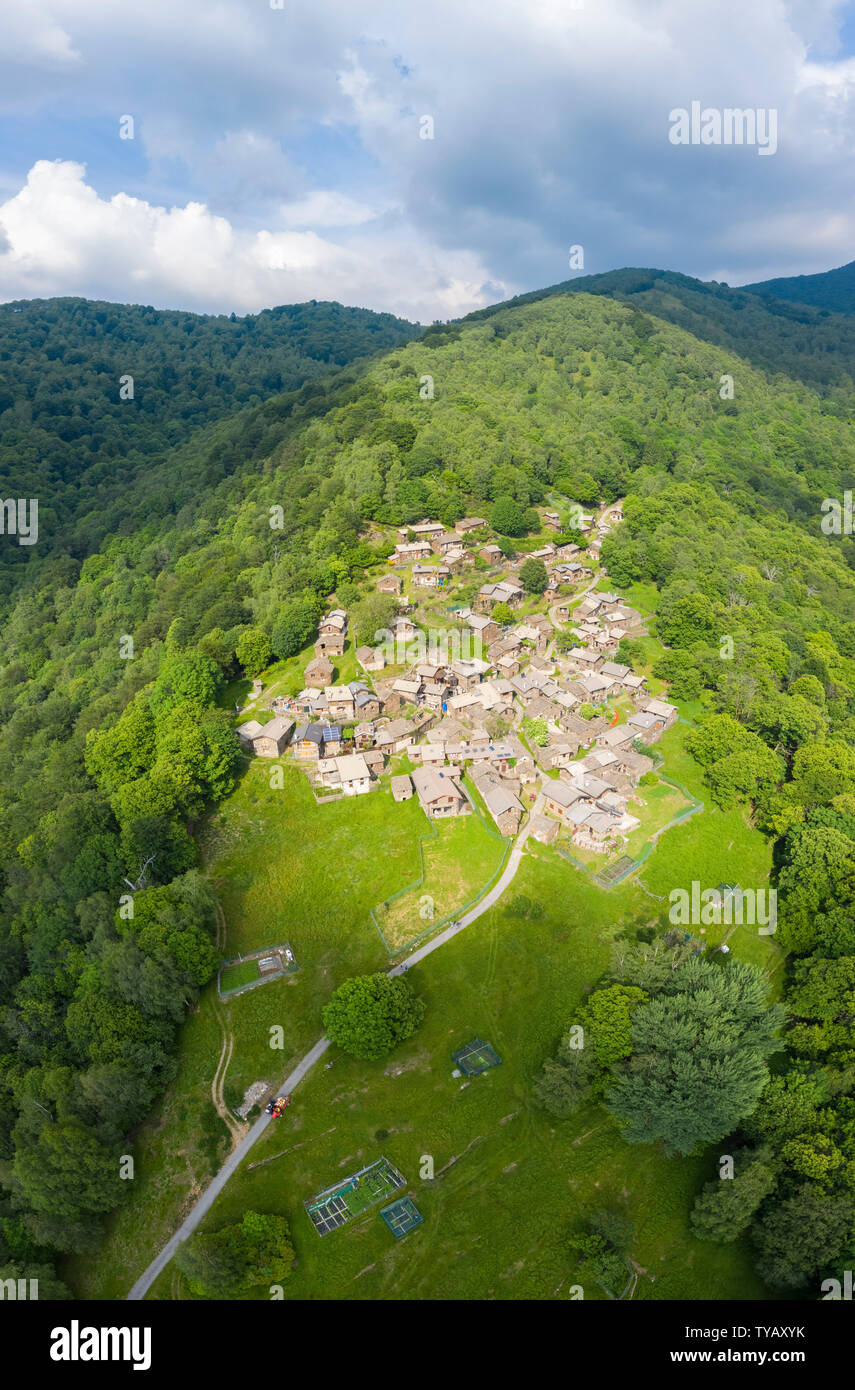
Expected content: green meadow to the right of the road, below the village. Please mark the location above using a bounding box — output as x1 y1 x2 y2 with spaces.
150 847 774 1300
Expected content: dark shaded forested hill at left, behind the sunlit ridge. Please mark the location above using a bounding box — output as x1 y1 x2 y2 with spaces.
0 299 421 599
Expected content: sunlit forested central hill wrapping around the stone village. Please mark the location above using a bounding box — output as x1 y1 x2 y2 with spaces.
0 282 855 1289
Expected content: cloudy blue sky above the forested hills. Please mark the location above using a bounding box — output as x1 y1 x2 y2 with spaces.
0 0 855 322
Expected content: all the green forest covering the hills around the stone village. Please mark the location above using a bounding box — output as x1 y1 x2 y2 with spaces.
0 271 855 1297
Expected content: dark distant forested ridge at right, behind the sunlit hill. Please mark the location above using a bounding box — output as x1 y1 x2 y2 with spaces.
458 267 855 400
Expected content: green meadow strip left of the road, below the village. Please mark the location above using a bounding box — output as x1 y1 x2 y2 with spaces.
67 760 502 1298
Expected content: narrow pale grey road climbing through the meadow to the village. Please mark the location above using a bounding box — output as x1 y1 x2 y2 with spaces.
128 791 544 1302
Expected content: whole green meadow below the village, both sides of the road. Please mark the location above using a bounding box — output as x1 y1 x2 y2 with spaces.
70 578 783 1300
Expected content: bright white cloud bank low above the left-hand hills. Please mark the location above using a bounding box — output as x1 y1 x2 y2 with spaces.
0 160 509 321
